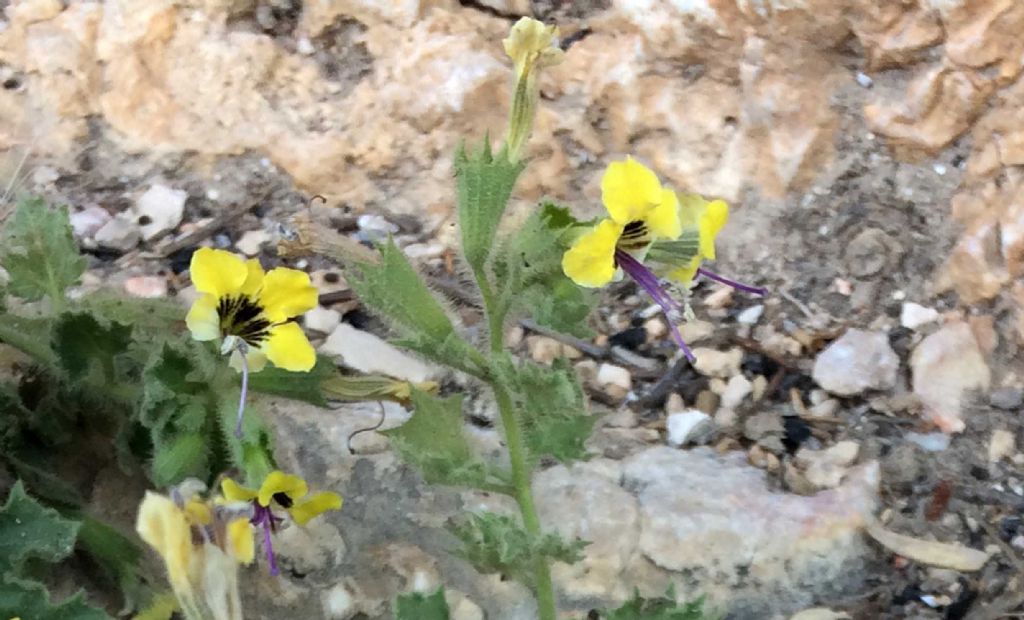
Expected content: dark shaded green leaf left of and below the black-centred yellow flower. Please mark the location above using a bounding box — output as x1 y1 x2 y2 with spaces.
53 313 132 384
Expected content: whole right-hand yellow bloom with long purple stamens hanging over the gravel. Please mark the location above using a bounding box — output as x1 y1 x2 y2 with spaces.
562 158 764 360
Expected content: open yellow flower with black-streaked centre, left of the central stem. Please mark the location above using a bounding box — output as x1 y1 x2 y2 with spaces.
185 248 317 371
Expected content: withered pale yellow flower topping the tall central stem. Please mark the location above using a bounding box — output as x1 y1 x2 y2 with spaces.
502 17 563 162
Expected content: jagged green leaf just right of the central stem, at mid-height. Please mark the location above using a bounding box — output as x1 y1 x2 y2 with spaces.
495 357 596 463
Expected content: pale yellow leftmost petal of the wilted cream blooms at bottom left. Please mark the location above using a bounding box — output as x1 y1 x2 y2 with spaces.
135 491 193 590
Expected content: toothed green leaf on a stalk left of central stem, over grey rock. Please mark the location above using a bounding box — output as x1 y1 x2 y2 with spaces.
381 388 504 489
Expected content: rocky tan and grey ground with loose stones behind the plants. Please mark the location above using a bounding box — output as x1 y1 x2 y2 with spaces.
0 0 1024 620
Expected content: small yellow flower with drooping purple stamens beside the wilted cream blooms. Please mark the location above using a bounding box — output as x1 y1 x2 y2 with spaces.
220 471 342 575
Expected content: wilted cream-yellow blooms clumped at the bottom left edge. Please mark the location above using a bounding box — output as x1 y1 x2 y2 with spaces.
135 481 254 620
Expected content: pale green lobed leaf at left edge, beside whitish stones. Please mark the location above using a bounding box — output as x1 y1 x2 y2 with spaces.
0 198 86 305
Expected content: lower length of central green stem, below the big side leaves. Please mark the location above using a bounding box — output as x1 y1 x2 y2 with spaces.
492 383 556 620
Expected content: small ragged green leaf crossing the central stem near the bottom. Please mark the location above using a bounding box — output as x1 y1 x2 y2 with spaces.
451 512 589 587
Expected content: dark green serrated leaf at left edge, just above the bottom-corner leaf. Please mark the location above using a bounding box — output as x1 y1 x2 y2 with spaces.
0 481 79 577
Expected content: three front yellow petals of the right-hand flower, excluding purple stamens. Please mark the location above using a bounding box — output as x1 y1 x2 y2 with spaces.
562 158 682 288
